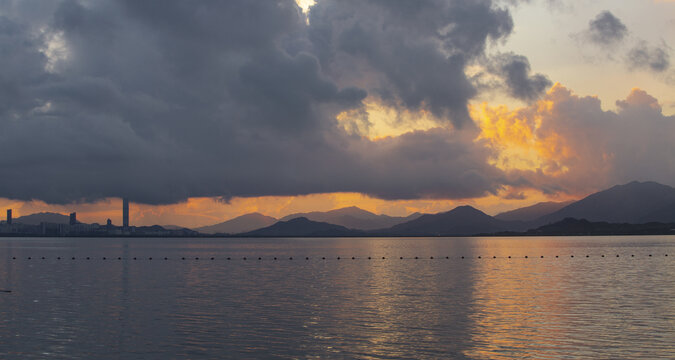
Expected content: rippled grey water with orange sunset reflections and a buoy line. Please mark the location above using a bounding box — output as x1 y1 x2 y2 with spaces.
0 236 675 359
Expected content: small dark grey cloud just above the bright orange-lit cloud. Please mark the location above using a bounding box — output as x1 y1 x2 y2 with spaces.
493 54 553 101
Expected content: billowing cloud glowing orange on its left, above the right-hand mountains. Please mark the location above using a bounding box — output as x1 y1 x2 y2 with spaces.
476 84 675 195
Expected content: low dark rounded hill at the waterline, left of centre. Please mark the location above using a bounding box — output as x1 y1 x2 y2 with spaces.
239 217 365 237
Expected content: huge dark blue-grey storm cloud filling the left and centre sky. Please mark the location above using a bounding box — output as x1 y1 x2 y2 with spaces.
0 0 524 203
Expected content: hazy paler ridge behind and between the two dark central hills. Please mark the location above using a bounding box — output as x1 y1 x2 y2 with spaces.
281 206 422 230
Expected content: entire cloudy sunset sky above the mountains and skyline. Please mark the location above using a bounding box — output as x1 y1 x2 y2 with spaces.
0 0 675 227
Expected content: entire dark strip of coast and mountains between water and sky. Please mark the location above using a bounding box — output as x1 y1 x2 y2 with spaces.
0 182 675 237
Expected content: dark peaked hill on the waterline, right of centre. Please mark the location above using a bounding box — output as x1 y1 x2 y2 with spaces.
377 206 525 236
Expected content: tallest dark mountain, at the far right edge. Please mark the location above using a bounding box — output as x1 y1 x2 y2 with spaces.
536 181 675 225
